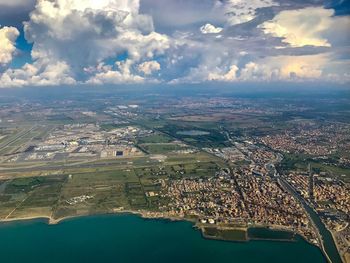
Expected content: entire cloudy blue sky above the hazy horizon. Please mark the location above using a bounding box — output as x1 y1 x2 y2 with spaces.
0 0 350 88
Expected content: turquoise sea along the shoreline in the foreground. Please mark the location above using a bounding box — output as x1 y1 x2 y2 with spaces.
0 215 325 263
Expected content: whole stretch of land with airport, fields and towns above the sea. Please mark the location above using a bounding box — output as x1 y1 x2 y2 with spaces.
0 87 350 258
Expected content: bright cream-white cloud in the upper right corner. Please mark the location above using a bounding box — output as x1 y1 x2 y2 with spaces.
260 7 350 47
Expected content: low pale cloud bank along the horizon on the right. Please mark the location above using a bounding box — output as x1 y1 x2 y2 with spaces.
171 53 350 83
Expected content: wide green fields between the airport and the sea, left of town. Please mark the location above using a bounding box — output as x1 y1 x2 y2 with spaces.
0 153 224 219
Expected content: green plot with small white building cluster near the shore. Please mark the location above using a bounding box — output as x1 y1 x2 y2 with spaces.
54 170 138 218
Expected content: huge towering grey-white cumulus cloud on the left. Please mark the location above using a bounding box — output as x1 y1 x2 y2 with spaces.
0 0 169 86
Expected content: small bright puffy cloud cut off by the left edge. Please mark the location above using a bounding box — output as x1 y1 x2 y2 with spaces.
0 26 19 65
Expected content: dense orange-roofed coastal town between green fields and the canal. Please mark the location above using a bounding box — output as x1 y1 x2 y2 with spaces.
162 170 319 244
